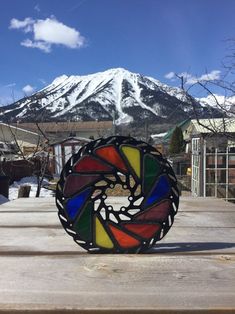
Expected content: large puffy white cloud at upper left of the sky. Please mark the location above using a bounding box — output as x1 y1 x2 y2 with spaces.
9 17 85 53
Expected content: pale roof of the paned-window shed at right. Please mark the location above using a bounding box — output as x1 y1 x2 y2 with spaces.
191 118 235 133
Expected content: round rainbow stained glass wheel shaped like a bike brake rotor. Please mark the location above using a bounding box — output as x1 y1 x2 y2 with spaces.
56 136 179 253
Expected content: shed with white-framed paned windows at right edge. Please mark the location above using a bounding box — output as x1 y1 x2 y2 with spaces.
187 118 235 201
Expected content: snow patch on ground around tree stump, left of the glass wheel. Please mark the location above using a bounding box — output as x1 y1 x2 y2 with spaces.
9 177 53 201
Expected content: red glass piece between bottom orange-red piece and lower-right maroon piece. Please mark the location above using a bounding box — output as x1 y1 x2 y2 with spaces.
123 223 161 239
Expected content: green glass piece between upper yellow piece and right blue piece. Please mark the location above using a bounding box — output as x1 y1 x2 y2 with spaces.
143 154 161 194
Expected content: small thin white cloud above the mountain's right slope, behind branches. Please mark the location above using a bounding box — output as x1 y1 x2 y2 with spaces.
165 70 221 85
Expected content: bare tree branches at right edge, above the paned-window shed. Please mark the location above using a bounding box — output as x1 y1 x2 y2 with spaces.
170 63 235 134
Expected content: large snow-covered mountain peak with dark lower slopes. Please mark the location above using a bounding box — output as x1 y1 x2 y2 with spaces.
0 68 220 124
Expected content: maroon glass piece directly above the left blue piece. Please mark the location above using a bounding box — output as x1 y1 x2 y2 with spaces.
64 174 100 197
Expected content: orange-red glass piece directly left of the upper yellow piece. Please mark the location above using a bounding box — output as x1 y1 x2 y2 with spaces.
95 145 127 172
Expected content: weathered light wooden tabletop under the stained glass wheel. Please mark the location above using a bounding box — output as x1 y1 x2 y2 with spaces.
0 197 235 314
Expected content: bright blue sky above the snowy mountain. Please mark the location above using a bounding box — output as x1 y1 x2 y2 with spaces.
0 0 235 104
